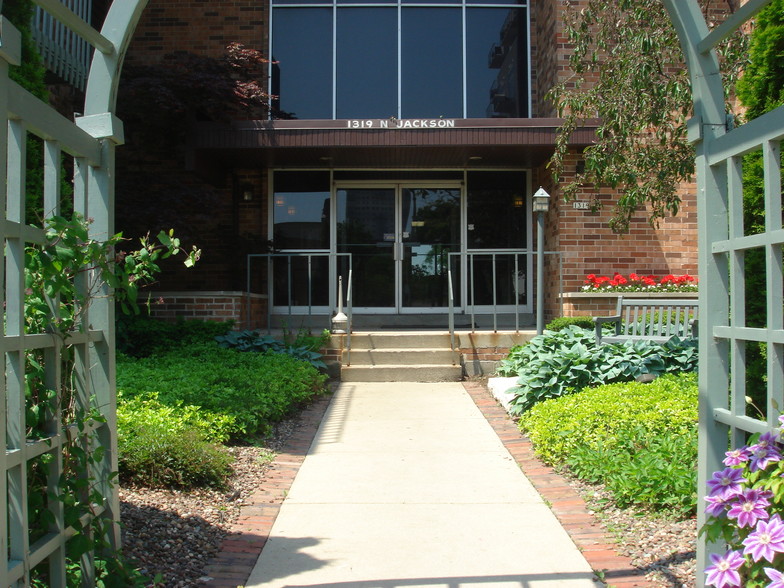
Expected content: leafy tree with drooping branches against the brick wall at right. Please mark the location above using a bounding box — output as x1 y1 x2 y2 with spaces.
548 0 747 232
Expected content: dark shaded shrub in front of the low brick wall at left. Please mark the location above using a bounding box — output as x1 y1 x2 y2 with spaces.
117 314 234 357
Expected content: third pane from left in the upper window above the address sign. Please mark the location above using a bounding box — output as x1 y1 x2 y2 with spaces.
401 8 463 118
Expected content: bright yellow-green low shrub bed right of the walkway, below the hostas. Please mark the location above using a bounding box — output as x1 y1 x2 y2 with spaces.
520 374 697 517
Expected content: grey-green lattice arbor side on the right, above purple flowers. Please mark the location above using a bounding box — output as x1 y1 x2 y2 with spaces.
664 0 784 586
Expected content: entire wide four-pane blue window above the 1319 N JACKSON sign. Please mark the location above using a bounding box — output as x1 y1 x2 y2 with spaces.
271 0 530 119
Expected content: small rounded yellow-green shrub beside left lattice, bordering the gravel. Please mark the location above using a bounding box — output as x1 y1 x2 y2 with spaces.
119 425 233 489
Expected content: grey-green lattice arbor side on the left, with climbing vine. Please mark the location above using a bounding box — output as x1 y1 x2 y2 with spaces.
0 0 146 588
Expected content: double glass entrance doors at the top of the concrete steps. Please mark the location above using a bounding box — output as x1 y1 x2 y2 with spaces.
336 184 461 313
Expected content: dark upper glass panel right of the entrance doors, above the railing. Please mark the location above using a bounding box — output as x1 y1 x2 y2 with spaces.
467 171 528 249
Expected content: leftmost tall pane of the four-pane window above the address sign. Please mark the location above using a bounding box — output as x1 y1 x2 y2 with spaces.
272 8 332 119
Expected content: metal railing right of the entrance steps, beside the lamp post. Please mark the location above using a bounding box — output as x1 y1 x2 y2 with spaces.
447 249 563 348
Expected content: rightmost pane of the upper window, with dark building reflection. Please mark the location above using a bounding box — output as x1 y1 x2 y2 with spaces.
466 8 528 118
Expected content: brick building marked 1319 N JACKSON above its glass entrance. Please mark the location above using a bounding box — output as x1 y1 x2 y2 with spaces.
112 0 697 327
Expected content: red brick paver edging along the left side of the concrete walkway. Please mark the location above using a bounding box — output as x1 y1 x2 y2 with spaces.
205 395 332 588
